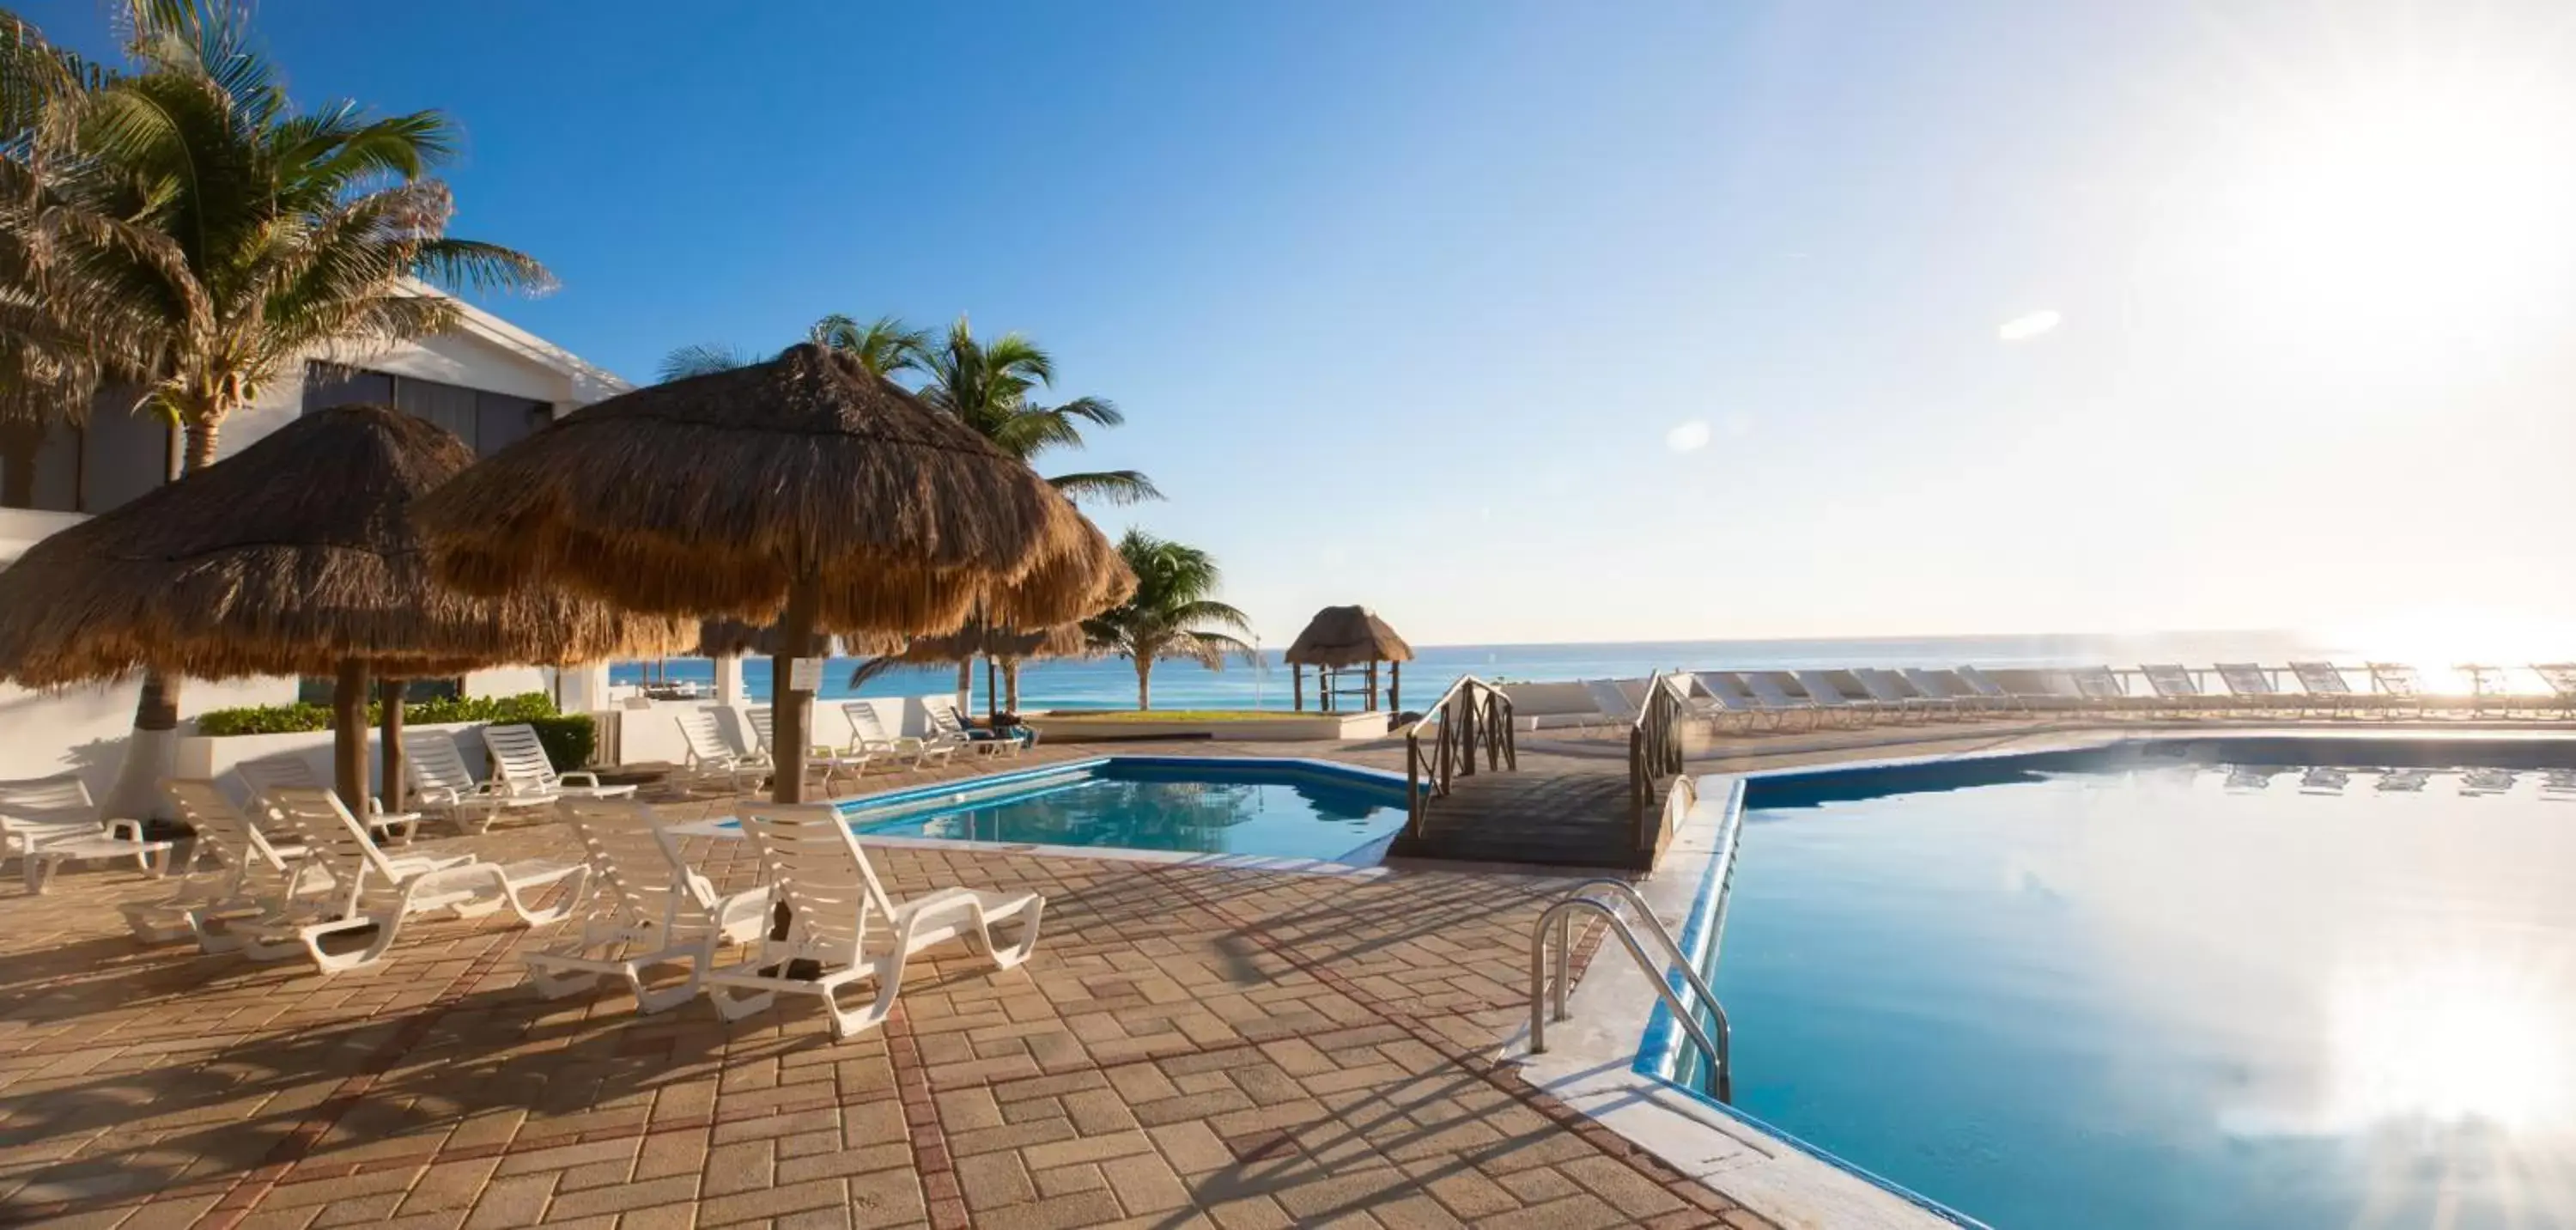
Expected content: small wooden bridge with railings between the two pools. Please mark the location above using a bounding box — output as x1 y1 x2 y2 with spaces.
1388 676 1682 872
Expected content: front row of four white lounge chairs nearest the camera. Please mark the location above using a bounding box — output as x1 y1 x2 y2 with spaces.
22 779 1046 1037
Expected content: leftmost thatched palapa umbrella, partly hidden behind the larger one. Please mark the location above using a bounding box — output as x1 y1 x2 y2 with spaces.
0 405 693 802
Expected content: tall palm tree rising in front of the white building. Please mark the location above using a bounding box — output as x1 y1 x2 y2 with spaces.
31 0 551 815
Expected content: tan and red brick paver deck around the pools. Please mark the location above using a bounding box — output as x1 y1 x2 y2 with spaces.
0 730 2195 1230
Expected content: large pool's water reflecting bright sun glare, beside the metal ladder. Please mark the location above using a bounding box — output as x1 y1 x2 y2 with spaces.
1716 761 2576 1230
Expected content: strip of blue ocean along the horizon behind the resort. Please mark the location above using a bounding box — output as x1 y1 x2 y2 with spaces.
611 632 2380 709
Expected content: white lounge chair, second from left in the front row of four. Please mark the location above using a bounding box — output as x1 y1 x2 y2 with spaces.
242 787 587 975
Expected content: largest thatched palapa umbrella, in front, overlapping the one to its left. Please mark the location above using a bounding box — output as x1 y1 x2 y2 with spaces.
417 343 1092 802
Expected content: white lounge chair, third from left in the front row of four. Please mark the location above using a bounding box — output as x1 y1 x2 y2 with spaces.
528 797 770 1014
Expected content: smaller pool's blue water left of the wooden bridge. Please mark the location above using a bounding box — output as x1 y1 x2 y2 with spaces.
845 758 1404 864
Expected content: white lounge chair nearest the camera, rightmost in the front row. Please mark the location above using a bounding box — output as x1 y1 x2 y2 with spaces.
706 805 1046 1039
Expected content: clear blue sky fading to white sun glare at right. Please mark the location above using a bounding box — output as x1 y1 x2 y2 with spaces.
26 0 2576 652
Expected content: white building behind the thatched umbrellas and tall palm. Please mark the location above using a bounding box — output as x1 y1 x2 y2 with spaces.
0 294 629 797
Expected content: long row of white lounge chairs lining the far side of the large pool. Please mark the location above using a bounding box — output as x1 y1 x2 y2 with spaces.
1584 663 2576 733
